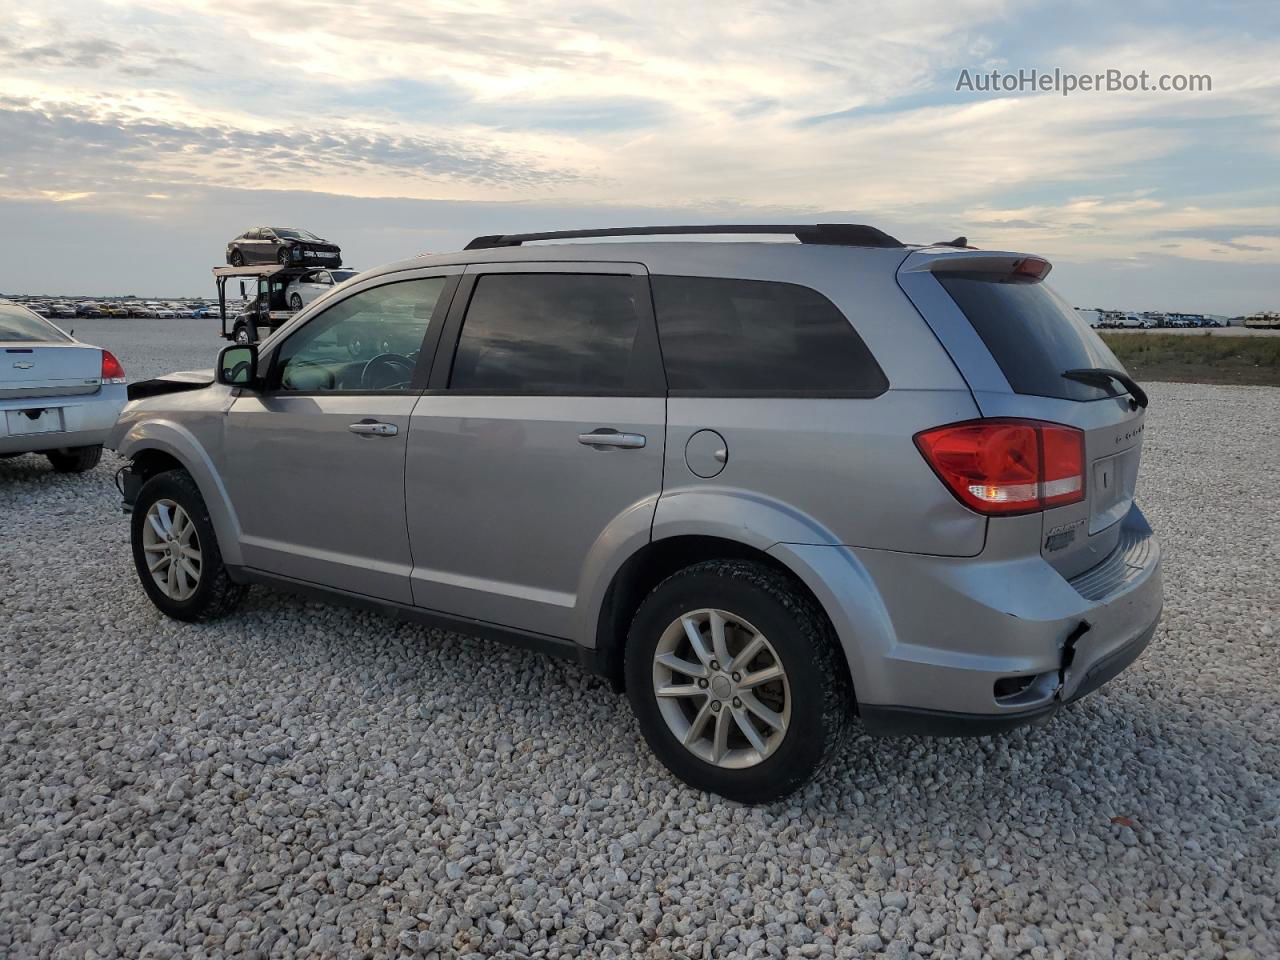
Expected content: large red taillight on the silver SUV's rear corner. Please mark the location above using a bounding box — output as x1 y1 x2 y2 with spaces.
915 420 1084 516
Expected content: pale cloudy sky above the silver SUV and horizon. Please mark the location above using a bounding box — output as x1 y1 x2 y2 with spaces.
0 0 1280 315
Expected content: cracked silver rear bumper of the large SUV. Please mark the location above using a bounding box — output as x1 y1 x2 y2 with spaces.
788 506 1164 735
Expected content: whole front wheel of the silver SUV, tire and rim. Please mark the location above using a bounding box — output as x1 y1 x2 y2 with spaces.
129 470 247 621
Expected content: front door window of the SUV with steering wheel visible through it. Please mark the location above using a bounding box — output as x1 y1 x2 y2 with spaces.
273 276 444 393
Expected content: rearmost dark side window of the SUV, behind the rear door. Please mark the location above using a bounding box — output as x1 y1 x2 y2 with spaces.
652 276 888 397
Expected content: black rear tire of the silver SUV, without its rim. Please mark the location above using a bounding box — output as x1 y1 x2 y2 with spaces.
623 561 854 804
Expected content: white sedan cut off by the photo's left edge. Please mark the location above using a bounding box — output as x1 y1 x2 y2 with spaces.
0 302 128 474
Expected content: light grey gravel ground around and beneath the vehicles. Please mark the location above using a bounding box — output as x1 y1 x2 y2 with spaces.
0 321 1280 959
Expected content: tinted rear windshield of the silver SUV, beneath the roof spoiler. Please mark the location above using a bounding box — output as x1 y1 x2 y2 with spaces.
937 274 1124 401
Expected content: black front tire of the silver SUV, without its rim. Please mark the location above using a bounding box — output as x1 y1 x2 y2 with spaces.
129 470 248 622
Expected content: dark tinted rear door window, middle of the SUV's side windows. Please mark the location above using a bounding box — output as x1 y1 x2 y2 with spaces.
449 274 644 396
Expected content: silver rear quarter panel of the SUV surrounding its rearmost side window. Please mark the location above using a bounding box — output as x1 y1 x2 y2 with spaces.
646 243 987 557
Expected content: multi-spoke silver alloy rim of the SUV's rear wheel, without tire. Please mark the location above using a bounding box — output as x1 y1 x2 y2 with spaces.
653 609 791 769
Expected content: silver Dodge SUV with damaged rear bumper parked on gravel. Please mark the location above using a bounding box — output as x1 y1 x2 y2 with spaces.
111 224 1162 803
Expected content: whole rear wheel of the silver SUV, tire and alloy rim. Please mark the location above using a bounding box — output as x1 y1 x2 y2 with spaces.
625 561 852 804
